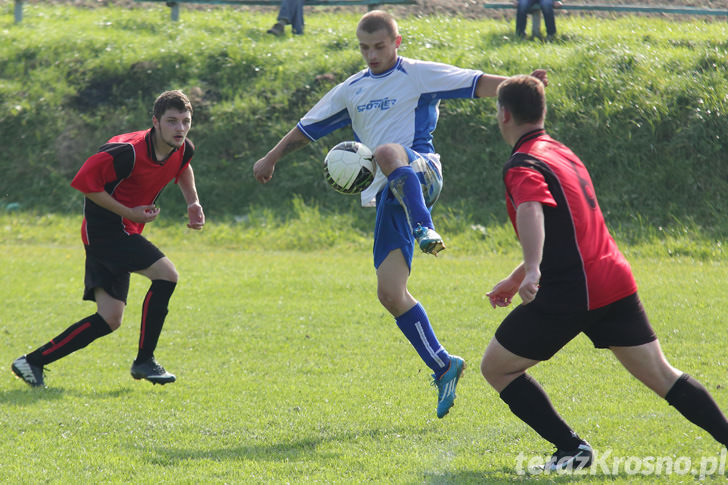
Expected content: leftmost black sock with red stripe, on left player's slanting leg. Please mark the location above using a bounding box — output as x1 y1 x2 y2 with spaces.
26 313 111 366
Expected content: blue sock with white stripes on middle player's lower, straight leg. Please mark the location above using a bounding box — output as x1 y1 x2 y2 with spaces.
396 303 450 378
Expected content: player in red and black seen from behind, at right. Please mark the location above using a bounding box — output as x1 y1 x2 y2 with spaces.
481 76 728 470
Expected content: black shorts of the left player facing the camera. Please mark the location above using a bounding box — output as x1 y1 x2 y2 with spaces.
83 234 164 303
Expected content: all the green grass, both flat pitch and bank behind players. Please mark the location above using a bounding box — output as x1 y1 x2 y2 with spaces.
0 0 728 485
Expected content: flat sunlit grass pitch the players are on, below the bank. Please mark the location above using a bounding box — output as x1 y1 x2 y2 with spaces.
0 215 728 484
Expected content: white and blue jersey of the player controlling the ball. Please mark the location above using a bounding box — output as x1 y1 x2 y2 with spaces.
297 57 483 206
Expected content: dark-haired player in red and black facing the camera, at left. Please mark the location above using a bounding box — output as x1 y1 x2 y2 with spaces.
12 91 205 387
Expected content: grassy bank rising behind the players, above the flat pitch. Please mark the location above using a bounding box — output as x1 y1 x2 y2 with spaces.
0 5 728 238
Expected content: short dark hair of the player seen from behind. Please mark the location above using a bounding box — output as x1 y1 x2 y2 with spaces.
497 74 546 124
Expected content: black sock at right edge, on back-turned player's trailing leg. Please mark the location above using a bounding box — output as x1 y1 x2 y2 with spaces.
665 374 728 446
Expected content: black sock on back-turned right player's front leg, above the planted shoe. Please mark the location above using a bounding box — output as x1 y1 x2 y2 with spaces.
500 374 583 450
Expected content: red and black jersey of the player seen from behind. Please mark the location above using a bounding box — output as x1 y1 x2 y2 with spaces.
503 130 637 311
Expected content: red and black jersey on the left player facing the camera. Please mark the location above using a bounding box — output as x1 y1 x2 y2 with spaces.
71 128 195 245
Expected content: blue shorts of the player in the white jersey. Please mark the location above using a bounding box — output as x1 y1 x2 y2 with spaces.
374 147 442 269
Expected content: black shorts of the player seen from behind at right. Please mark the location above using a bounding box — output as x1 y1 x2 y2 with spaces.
495 293 657 360
